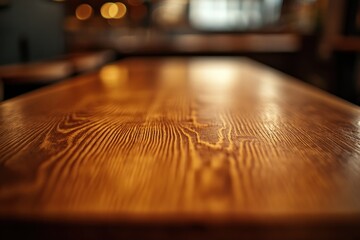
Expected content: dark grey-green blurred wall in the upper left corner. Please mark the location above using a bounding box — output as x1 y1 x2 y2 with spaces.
0 0 64 64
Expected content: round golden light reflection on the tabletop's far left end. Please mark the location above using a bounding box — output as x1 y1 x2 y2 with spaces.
99 65 128 88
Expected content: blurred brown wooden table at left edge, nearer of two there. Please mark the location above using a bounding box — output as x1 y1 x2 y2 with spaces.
0 61 73 99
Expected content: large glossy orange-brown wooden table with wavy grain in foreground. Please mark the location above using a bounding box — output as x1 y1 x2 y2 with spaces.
0 58 360 239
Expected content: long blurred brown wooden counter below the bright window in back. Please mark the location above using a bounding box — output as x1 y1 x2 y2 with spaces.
107 32 301 55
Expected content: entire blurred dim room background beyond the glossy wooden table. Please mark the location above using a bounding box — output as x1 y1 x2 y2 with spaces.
0 0 360 104
